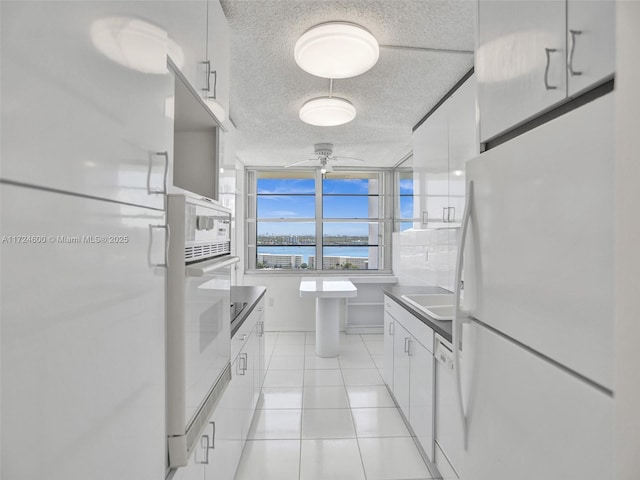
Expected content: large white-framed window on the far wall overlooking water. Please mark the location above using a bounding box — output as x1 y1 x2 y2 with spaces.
246 170 393 273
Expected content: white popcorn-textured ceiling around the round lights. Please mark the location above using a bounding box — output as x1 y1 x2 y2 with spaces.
221 0 474 166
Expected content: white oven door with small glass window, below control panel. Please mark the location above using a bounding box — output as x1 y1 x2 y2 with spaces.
184 262 232 426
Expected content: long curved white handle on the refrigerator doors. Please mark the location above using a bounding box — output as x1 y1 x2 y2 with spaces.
452 180 473 450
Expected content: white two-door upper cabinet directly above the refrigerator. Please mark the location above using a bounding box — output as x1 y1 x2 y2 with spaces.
476 0 614 142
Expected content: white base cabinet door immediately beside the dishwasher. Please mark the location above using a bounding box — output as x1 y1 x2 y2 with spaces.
409 338 434 461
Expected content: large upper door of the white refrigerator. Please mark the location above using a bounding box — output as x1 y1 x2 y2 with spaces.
464 94 614 389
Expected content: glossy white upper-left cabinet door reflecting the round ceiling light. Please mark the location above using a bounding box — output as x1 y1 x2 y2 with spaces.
0 1 173 208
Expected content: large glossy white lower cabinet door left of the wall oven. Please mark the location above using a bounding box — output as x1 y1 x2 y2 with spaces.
0 184 166 480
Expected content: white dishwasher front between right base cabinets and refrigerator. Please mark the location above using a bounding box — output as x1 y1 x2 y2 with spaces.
434 334 464 480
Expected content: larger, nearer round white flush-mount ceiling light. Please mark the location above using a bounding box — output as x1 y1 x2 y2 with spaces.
294 22 380 78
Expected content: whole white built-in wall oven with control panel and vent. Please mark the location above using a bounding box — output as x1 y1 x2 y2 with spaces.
167 195 238 468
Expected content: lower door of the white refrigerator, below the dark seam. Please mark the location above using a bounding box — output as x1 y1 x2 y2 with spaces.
462 323 614 480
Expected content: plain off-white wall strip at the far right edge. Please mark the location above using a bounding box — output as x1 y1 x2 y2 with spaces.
614 1 640 480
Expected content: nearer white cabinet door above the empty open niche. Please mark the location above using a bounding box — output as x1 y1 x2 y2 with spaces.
167 0 207 93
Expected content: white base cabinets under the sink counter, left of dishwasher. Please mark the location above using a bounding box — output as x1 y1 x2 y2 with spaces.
385 296 434 460
